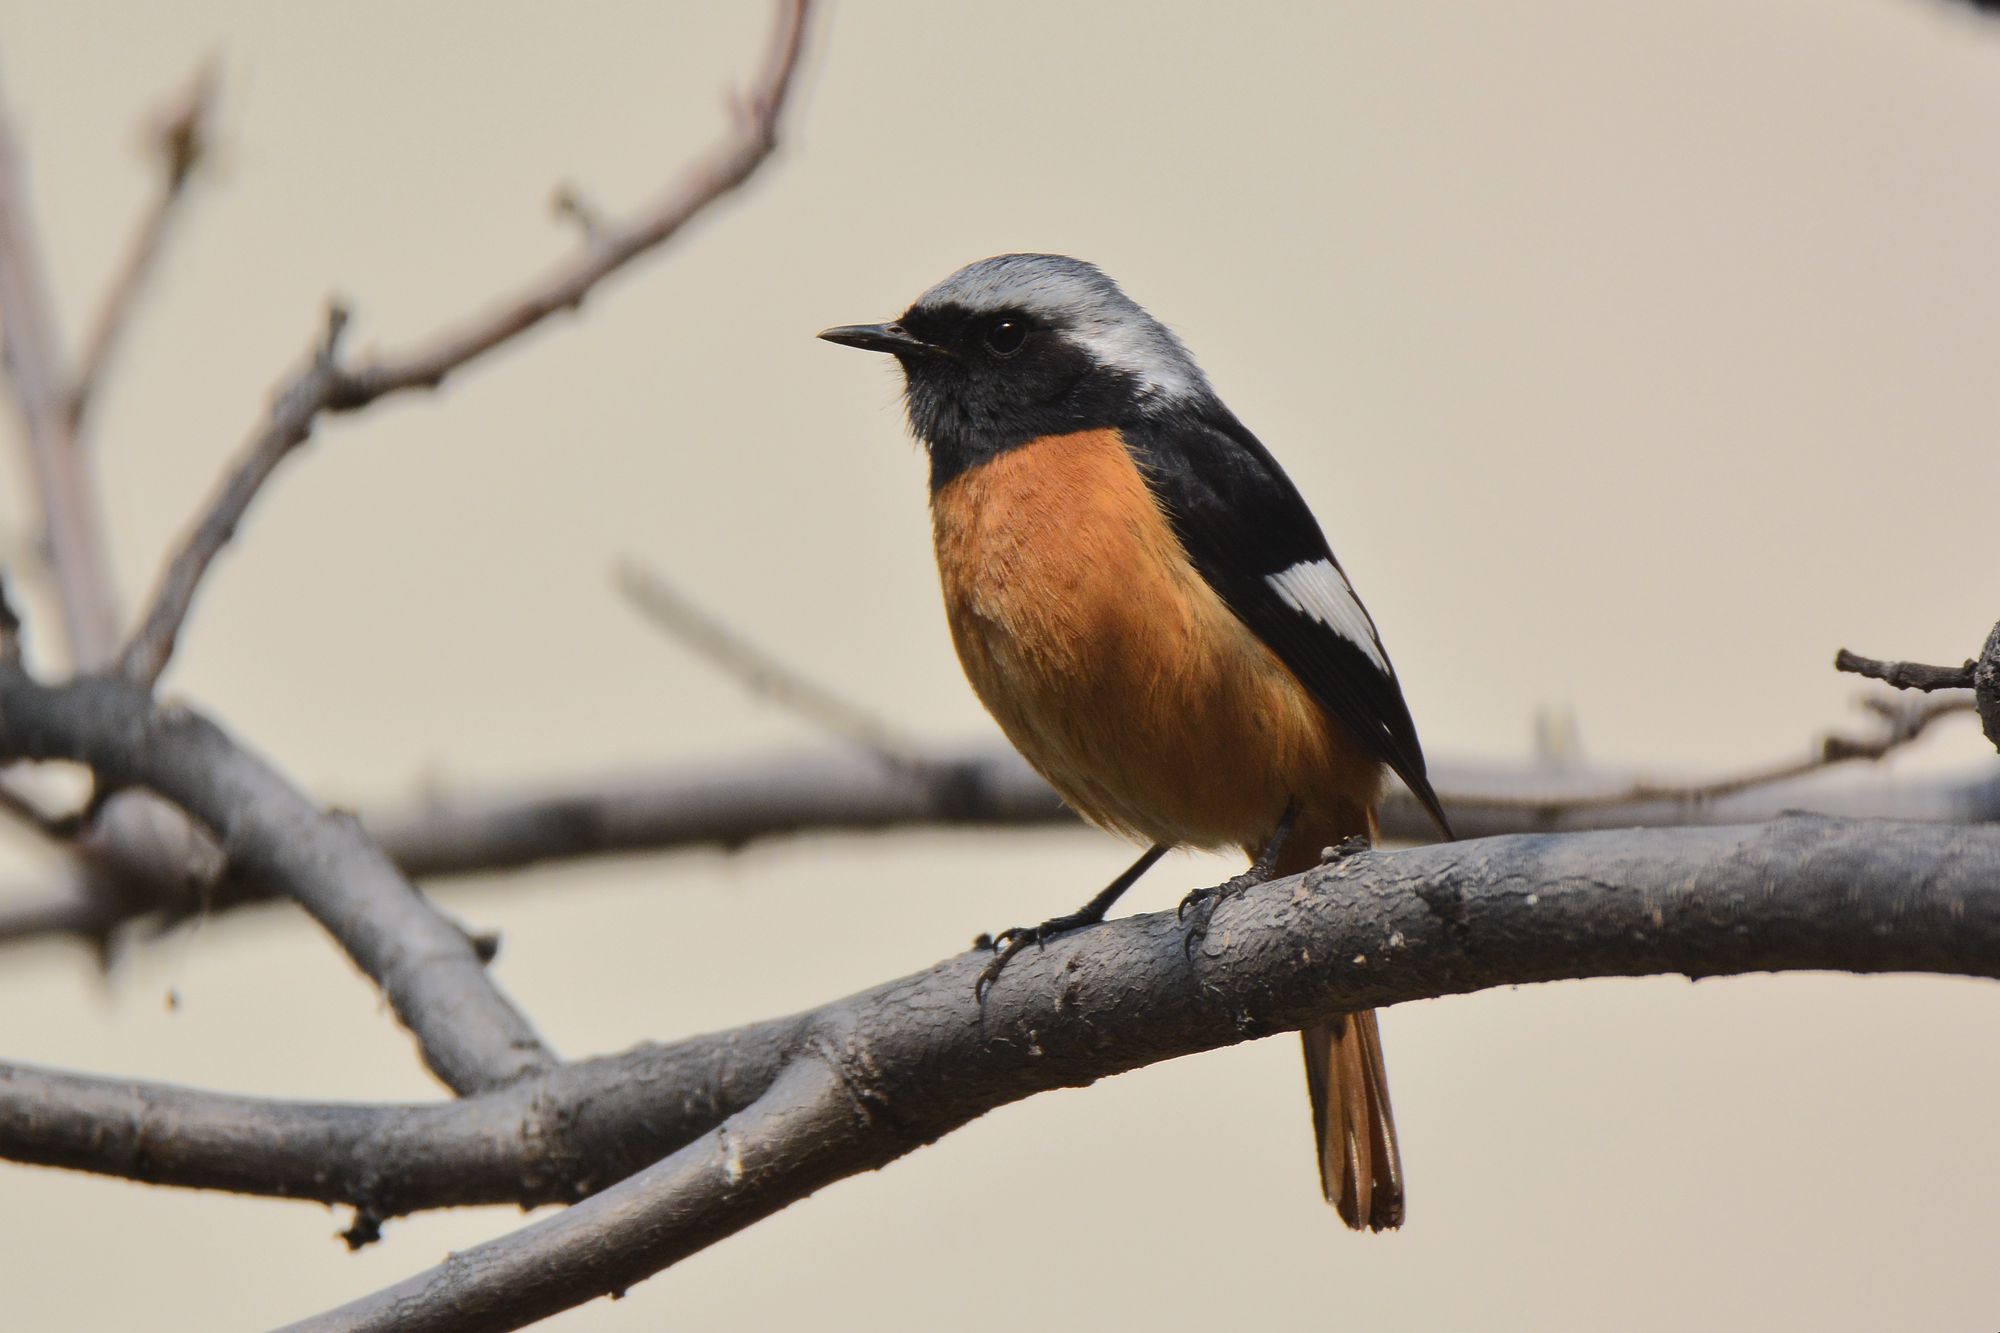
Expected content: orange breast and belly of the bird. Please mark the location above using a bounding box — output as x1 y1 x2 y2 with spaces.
932 430 1382 849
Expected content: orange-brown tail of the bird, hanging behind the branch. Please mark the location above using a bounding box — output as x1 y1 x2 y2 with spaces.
1278 811 1402 1231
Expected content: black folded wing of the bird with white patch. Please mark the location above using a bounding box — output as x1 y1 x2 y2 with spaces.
1124 402 1452 837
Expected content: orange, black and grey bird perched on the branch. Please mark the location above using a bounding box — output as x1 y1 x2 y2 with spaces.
818 254 1450 1231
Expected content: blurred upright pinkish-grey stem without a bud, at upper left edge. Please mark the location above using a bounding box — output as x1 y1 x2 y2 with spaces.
0 65 118 671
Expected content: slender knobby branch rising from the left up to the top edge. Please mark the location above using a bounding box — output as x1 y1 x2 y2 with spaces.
118 0 810 687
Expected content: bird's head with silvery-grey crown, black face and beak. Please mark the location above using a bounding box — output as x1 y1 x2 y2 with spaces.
820 254 1208 484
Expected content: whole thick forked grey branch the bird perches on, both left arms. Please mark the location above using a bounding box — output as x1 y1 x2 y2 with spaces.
0 817 2000 1304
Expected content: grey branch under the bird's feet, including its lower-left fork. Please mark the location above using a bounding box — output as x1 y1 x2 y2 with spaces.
234 817 2000 1331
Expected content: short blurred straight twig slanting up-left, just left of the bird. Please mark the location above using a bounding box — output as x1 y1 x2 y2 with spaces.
616 560 926 771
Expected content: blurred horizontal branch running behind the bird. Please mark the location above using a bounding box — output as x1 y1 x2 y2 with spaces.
0 720 2000 945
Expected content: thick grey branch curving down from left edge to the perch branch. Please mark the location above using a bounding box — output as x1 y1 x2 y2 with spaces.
0 669 554 1091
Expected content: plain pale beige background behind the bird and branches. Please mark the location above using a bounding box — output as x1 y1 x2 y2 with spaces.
0 0 2000 1333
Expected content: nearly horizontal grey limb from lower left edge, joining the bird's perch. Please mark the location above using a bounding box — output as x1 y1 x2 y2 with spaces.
0 1017 806 1219
